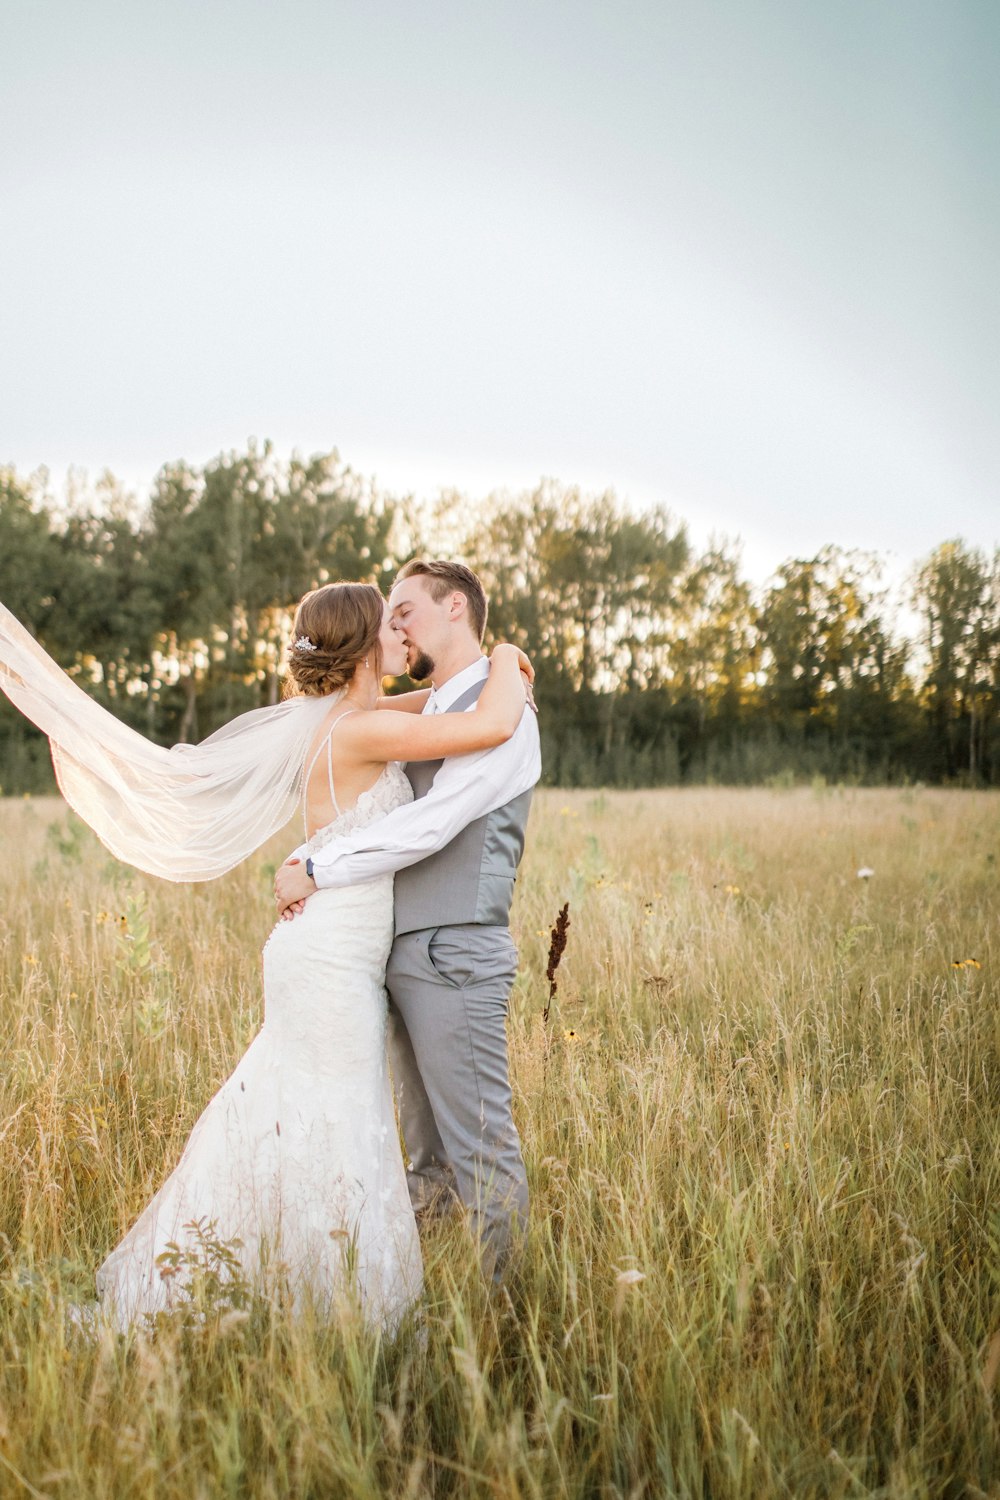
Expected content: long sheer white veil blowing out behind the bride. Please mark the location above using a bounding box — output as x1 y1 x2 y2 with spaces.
0 605 335 881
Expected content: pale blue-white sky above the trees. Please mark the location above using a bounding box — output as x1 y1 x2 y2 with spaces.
0 0 1000 581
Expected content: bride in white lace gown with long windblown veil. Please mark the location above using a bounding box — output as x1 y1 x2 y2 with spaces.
0 584 525 1328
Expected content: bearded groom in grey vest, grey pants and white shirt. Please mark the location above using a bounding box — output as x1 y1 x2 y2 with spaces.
276 561 541 1280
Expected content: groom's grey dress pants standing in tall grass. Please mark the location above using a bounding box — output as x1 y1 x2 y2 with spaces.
385 923 528 1281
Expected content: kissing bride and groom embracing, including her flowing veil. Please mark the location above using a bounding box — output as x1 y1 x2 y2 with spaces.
0 561 540 1328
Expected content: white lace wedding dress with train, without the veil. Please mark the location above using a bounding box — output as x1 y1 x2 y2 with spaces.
97 765 421 1329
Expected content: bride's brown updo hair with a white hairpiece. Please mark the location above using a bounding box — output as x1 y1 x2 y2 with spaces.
288 584 385 698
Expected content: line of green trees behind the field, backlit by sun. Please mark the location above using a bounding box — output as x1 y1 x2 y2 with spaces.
0 444 1000 794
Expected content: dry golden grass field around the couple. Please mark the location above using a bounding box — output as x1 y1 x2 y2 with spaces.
0 788 1000 1500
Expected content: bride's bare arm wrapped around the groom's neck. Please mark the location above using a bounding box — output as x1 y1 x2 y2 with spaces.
340 645 525 761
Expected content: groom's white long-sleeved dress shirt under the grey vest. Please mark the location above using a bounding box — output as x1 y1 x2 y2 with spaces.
307 657 541 888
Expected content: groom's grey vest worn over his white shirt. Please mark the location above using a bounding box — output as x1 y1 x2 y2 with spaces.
394 678 531 936
